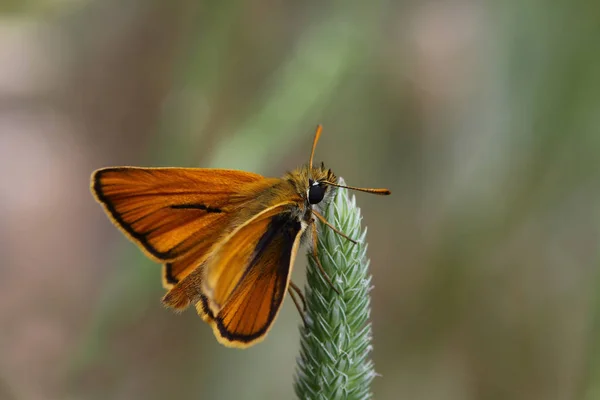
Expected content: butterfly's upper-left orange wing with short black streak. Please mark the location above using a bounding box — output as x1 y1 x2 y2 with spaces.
92 167 264 262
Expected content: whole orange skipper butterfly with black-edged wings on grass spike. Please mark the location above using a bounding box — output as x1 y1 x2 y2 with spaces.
91 125 390 348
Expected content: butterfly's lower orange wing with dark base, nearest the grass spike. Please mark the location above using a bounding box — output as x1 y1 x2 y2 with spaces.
196 203 305 347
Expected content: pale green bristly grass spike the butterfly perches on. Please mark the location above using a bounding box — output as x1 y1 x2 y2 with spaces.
294 181 375 400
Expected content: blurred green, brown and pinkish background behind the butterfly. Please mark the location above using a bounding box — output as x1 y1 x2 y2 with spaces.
0 0 600 400
